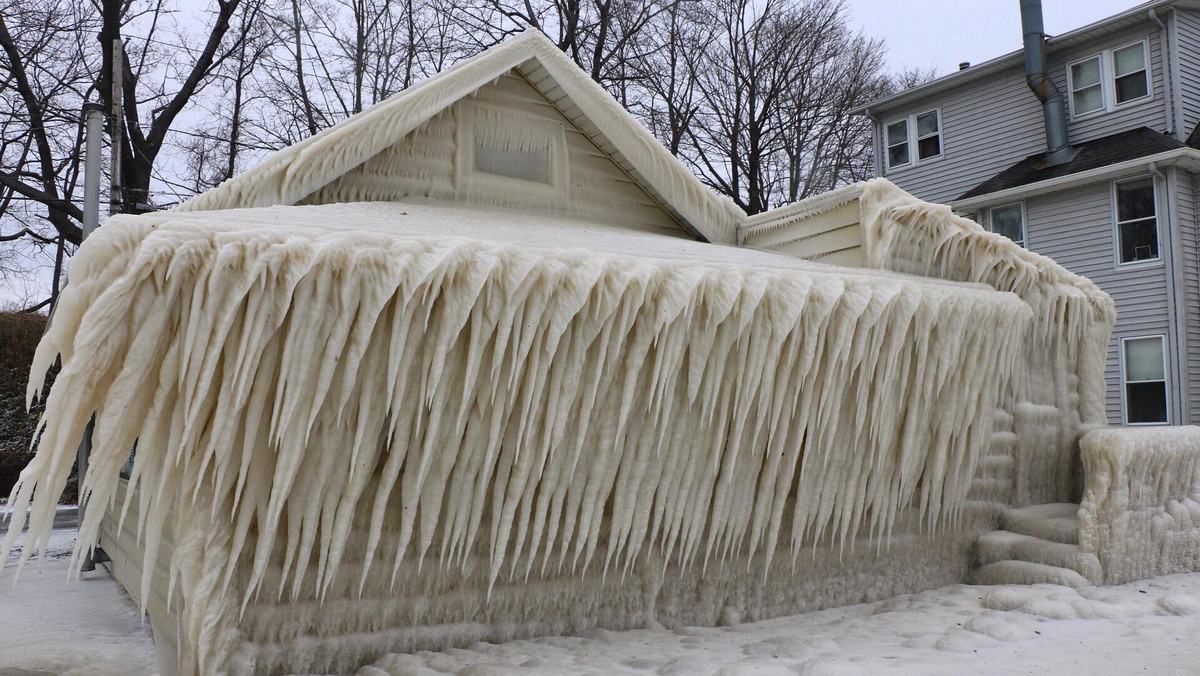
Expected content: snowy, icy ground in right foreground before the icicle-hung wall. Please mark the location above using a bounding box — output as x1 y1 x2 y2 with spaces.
359 574 1200 676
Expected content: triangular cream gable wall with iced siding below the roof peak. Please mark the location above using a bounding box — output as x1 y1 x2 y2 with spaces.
304 70 689 237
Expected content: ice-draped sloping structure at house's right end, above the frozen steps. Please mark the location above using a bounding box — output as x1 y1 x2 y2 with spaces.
859 179 1116 504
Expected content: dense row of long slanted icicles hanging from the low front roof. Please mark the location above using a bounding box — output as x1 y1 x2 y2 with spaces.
0 198 1028 604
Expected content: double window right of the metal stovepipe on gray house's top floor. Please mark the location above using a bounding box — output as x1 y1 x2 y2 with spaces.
1067 40 1151 118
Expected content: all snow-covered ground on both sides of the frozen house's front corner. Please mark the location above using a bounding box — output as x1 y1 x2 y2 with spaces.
0 521 1200 676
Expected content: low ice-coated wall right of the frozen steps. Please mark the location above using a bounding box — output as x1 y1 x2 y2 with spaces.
1079 426 1200 585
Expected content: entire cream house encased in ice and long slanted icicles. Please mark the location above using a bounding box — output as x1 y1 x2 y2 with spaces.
6 26 1156 674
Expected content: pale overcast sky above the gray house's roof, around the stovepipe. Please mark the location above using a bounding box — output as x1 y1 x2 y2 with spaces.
847 0 1142 74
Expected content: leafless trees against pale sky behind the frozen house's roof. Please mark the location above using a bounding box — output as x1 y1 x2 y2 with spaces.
0 0 916 307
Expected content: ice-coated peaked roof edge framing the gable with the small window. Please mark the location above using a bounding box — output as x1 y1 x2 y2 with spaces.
176 29 745 244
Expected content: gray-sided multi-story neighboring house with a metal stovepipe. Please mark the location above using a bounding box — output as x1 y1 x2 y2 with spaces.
860 0 1200 425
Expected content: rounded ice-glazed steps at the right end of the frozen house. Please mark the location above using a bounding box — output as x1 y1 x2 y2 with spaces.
974 503 1100 587
